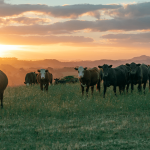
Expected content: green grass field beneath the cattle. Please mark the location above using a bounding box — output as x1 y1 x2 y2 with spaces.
0 83 150 150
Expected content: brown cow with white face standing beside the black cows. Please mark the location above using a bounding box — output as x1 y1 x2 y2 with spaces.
74 66 101 96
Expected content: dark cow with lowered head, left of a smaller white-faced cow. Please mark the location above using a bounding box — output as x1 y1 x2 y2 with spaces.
24 72 36 86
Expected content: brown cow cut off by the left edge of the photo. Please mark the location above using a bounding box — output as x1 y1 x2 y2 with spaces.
0 70 8 108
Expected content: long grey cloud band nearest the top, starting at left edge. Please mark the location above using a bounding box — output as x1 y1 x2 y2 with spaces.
0 1 122 19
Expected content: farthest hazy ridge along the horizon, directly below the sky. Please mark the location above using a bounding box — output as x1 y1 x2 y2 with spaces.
0 55 150 69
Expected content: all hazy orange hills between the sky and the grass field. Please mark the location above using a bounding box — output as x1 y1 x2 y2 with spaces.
0 55 150 86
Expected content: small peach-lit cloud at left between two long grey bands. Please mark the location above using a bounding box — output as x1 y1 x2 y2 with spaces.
0 17 51 25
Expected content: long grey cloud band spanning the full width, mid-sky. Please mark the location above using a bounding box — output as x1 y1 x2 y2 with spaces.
0 17 150 35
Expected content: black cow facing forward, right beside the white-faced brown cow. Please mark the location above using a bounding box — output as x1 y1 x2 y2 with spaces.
98 64 126 98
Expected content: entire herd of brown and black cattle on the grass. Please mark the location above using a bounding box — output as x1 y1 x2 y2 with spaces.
0 62 150 108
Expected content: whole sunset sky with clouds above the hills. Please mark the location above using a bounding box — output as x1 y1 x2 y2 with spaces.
0 0 150 61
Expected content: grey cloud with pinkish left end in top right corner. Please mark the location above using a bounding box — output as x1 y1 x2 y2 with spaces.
105 2 150 18
